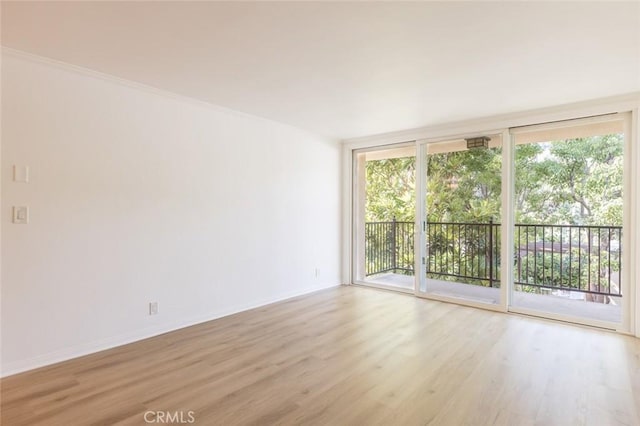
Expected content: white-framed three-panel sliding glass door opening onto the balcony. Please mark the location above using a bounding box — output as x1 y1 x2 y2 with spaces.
353 114 633 330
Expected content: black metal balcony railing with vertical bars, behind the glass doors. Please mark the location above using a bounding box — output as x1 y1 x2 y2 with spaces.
365 220 622 300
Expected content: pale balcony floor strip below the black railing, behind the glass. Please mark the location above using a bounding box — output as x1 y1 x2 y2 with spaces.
365 273 622 323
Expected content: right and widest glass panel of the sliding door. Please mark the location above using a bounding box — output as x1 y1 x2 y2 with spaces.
511 118 625 323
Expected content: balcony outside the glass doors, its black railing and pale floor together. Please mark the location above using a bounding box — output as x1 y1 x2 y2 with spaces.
365 220 622 322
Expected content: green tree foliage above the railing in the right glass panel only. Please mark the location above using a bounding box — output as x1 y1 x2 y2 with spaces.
516 134 623 225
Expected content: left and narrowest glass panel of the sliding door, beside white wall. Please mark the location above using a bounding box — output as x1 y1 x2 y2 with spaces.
354 144 416 292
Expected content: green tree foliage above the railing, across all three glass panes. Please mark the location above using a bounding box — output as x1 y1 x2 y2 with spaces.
365 134 623 225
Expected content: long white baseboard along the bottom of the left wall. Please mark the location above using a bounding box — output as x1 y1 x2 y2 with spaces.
0 284 339 377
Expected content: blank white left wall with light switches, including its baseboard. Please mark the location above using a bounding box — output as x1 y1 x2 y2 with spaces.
1 50 340 375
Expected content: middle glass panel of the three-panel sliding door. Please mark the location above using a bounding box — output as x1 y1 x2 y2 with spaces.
419 135 502 305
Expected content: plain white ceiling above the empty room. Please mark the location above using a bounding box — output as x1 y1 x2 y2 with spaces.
2 2 640 138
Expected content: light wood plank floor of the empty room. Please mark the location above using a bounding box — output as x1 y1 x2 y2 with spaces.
1 287 640 426
